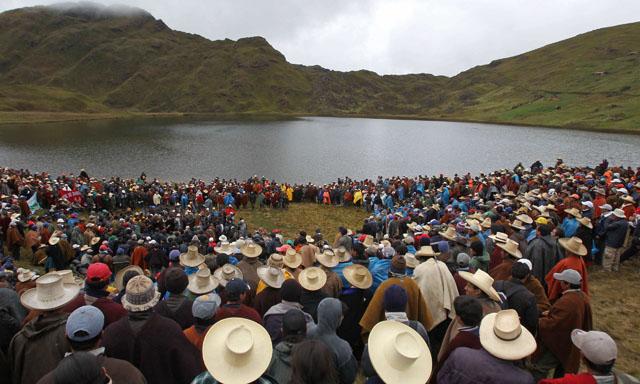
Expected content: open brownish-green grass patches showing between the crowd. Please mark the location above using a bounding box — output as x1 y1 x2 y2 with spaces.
7 203 640 376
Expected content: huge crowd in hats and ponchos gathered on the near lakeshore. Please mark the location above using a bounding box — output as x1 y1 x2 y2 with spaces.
0 160 640 384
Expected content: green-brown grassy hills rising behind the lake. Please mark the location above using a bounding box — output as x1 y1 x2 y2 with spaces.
0 3 640 130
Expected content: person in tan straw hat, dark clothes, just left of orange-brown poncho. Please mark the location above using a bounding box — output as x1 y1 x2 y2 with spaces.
337 264 373 360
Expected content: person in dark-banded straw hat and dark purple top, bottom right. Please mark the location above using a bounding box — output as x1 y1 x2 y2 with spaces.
438 309 536 384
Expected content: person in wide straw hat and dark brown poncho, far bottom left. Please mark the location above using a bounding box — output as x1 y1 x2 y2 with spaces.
7 273 80 384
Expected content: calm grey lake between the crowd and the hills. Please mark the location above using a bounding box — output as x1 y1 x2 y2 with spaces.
0 117 640 182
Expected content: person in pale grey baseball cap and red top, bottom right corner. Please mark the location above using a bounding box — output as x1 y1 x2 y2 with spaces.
539 329 640 384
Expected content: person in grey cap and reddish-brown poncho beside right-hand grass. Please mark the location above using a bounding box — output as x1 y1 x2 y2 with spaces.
532 269 593 380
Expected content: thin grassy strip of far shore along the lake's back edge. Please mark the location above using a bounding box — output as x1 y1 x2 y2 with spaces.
0 112 640 135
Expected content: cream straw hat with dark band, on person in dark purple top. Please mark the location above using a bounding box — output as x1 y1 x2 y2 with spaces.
480 309 536 360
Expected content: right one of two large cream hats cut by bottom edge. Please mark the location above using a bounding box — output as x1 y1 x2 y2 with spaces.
369 320 433 384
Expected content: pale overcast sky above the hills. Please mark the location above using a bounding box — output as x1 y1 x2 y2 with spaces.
0 0 640 75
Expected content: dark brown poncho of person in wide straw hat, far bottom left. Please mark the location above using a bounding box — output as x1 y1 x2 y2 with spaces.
7 313 71 384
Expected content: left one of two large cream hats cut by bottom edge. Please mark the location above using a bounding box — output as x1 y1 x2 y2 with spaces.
202 317 273 384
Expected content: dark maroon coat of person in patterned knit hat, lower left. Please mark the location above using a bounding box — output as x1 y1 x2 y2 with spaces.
102 313 204 384
